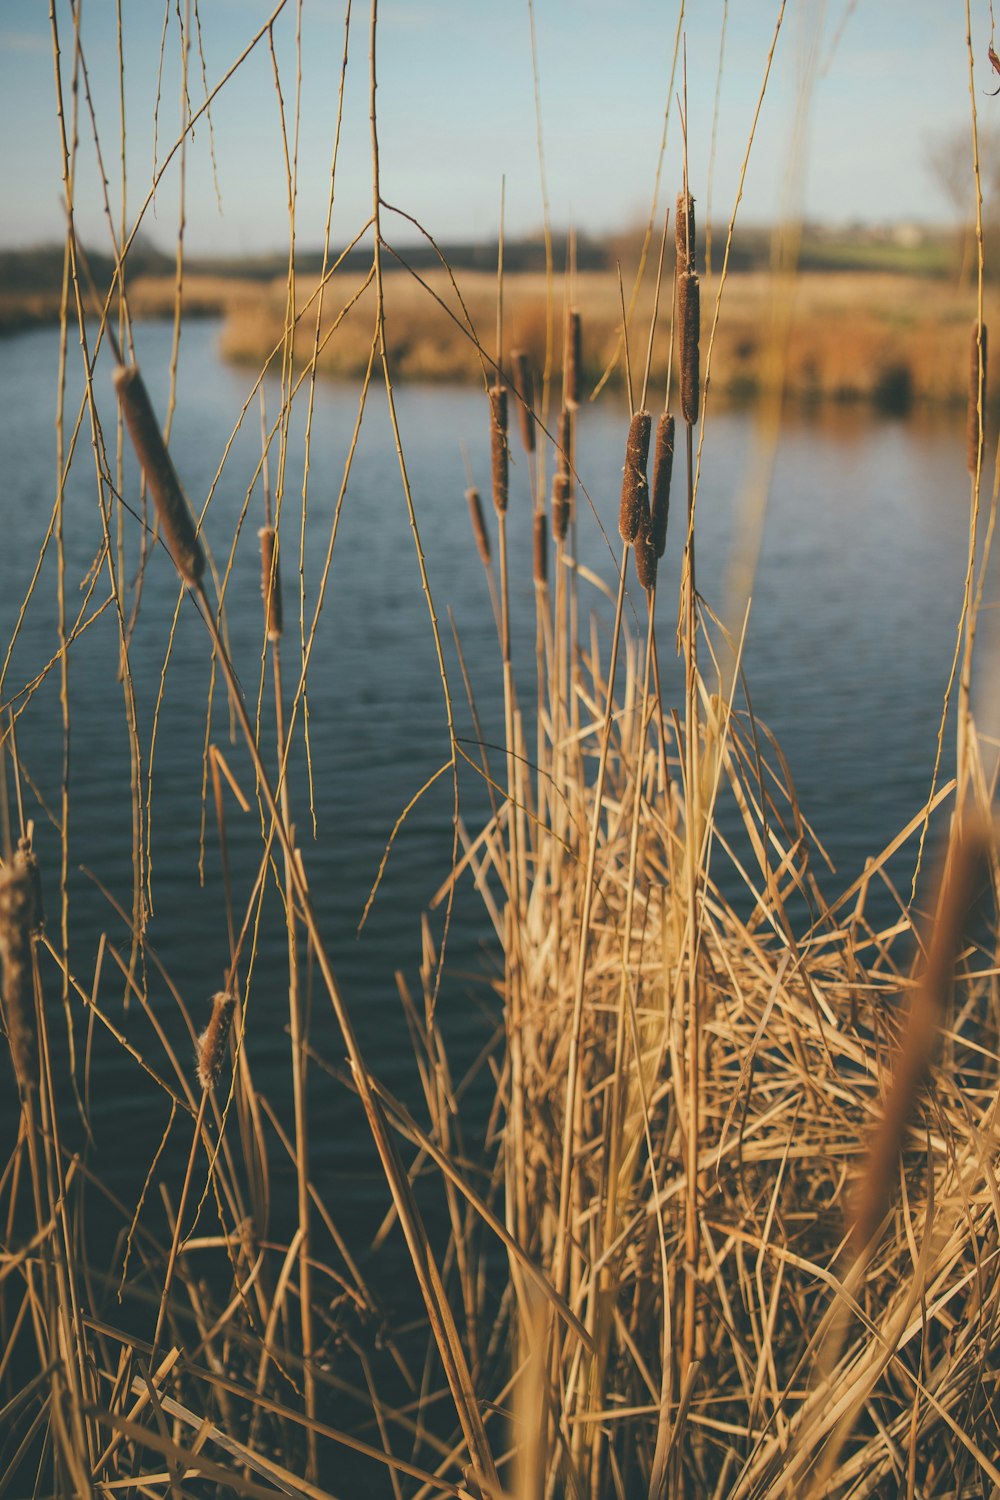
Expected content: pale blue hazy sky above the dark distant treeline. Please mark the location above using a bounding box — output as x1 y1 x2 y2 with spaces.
0 0 1000 252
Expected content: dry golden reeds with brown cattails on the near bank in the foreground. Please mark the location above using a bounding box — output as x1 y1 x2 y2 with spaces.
0 8 1000 1500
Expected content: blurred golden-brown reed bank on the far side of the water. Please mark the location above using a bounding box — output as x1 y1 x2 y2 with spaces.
0 270 997 411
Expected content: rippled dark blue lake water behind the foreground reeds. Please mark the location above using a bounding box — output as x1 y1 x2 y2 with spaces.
0 323 989 1241
